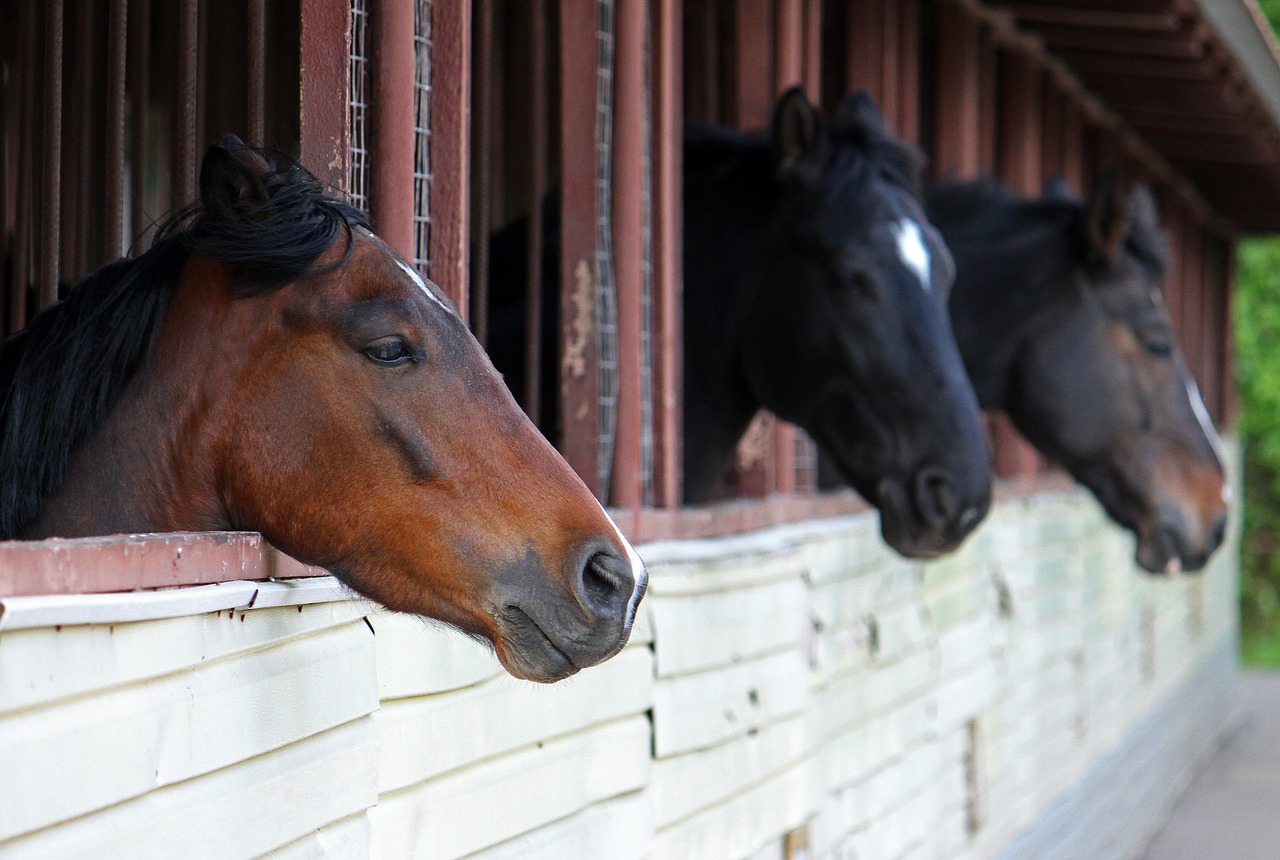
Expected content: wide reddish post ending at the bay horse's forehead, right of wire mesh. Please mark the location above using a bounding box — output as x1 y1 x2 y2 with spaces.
428 3 471 319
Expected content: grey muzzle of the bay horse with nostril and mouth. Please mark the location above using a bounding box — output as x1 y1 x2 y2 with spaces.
494 546 648 683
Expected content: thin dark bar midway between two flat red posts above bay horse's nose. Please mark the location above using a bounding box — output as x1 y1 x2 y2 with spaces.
525 0 547 424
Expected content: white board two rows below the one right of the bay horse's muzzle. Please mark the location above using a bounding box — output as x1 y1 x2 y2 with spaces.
650 714 809 828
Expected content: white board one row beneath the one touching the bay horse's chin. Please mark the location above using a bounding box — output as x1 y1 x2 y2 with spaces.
369 717 649 860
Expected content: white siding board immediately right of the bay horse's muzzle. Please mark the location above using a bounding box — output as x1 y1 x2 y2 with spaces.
648 578 808 677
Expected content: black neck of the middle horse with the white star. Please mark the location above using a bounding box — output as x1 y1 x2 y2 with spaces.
684 131 777 497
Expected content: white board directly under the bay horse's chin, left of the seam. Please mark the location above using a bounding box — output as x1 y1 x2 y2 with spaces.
374 646 653 793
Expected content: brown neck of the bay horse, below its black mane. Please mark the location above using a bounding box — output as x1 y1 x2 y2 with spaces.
24 259 232 538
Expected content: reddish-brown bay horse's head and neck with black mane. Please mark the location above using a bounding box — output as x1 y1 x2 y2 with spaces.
0 137 646 681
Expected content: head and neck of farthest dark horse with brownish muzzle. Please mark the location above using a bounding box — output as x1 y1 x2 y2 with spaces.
929 177 1226 572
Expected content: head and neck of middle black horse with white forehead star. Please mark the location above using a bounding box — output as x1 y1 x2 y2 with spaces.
685 88 991 557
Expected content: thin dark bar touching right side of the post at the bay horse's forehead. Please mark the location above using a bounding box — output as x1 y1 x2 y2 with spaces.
470 0 495 344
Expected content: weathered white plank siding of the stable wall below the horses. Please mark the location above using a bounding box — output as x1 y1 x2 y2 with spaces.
0 470 1236 860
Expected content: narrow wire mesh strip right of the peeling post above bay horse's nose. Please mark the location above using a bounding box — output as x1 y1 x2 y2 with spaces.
595 0 618 499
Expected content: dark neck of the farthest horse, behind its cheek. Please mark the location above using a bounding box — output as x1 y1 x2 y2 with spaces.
938 216 1074 410
